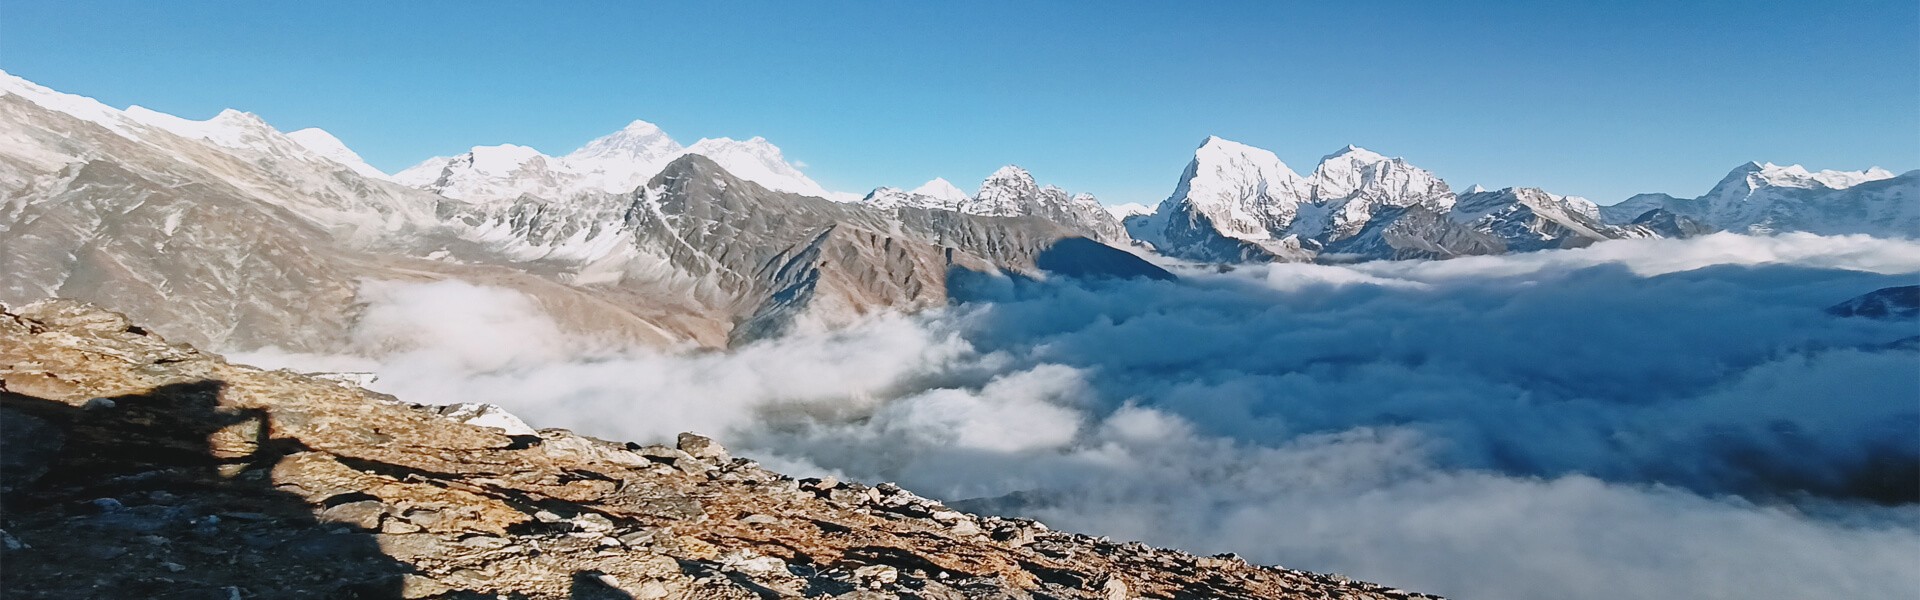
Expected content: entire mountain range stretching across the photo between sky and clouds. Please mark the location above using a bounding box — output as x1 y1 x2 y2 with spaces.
0 73 1920 350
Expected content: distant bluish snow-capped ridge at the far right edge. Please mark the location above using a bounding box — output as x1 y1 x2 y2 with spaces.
1601 163 1920 238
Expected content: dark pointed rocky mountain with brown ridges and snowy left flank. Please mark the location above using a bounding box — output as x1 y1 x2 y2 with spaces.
447 154 1165 338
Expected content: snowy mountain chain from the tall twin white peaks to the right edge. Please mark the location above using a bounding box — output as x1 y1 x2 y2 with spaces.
1125 137 1920 262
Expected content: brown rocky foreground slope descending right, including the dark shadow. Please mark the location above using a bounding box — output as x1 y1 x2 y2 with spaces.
0 300 1430 600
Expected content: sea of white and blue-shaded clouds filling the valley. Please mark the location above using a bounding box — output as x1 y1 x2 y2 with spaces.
236 235 1920 598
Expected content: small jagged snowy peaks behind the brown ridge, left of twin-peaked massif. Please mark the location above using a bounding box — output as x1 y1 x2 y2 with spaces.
860 165 1133 246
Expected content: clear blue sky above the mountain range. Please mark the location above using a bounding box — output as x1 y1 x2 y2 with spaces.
0 0 1920 204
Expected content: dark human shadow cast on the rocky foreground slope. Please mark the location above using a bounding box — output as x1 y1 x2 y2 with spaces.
0 381 411 600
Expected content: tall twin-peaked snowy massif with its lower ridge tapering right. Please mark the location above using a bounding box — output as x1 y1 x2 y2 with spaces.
1125 137 1651 262
